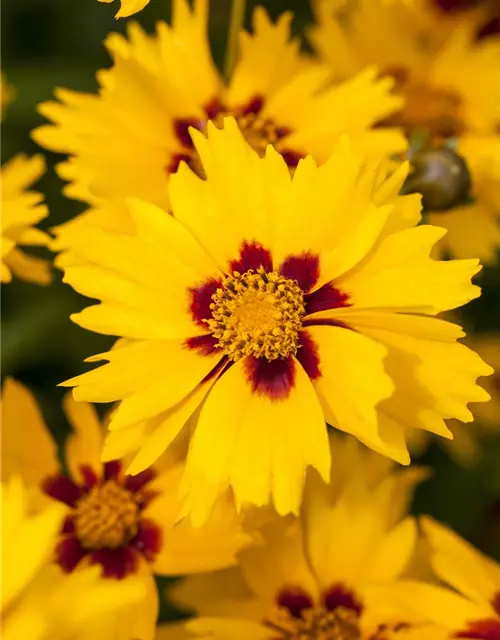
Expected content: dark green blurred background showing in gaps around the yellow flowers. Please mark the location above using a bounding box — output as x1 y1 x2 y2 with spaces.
0 0 500 580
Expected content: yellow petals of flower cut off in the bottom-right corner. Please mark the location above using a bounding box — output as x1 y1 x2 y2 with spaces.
392 518 500 640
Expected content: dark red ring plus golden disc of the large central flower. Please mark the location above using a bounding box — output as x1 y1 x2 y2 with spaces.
186 242 350 400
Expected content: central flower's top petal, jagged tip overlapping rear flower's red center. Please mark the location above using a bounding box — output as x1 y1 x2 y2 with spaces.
169 118 274 270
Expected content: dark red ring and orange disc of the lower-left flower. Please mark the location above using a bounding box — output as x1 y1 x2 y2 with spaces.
42 461 162 578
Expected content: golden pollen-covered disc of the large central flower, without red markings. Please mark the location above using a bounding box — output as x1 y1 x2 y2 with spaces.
207 267 305 360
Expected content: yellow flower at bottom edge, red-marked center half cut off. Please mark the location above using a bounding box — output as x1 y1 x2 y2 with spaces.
167 438 434 640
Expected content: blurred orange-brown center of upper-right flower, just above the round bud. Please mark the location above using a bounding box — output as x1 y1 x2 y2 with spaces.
388 68 466 143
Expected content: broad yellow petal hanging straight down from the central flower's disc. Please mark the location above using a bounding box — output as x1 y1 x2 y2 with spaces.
182 359 330 523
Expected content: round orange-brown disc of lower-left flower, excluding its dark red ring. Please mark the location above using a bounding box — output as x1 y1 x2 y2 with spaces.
74 480 139 549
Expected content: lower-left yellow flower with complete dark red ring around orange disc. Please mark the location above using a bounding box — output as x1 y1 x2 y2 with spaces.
2 379 250 640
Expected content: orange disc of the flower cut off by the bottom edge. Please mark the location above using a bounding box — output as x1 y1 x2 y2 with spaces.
264 607 361 640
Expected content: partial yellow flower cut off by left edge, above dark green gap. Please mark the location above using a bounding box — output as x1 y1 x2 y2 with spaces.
0 155 51 284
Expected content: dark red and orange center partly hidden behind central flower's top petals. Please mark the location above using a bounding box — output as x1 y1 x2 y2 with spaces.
168 97 303 176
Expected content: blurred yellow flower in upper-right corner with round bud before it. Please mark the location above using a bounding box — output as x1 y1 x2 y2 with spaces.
311 0 500 262
